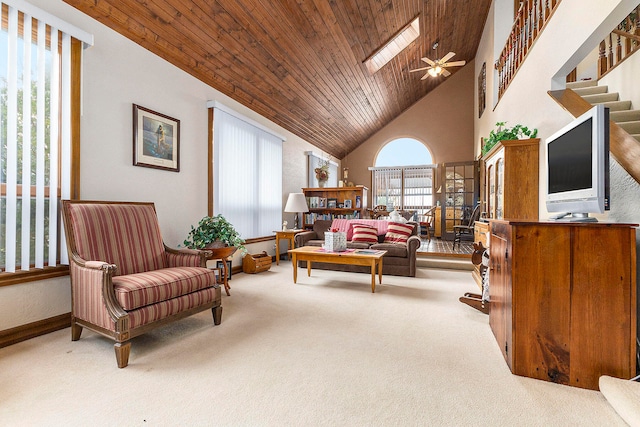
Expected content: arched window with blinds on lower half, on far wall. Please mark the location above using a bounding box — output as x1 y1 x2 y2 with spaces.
370 138 435 215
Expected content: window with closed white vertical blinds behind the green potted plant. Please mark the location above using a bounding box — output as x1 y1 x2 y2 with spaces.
213 104 284 240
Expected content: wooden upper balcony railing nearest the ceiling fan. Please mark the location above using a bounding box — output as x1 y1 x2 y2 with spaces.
495 0 561 100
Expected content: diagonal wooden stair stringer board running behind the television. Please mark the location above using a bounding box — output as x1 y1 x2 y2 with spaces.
547 89 640 184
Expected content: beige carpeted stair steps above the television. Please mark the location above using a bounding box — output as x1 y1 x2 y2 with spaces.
567 80 640 142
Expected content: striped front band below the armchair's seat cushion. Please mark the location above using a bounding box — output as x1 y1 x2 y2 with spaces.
129 288 219 329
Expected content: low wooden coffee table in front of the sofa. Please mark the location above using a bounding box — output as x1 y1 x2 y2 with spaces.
288 246 387 292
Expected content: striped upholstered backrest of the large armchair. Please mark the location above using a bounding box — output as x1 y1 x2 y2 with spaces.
69 203 165 275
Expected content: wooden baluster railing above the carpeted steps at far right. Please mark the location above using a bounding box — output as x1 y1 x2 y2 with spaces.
598 4 640 79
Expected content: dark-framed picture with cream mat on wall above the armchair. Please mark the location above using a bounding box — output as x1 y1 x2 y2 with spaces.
133 104 180 172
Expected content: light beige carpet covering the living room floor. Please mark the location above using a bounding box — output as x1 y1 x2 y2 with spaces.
0 262 624 427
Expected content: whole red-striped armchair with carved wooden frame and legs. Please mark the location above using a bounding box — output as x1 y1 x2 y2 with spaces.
62 200 222 368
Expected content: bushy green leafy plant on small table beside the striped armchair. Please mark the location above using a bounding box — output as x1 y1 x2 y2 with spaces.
184 214 247 253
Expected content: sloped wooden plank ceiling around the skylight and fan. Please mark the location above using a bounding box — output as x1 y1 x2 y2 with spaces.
64 0 491 159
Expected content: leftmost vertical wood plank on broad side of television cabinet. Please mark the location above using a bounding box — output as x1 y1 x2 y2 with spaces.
511 225 571 384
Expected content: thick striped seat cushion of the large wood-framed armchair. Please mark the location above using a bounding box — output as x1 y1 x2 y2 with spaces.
113 267 216 311
